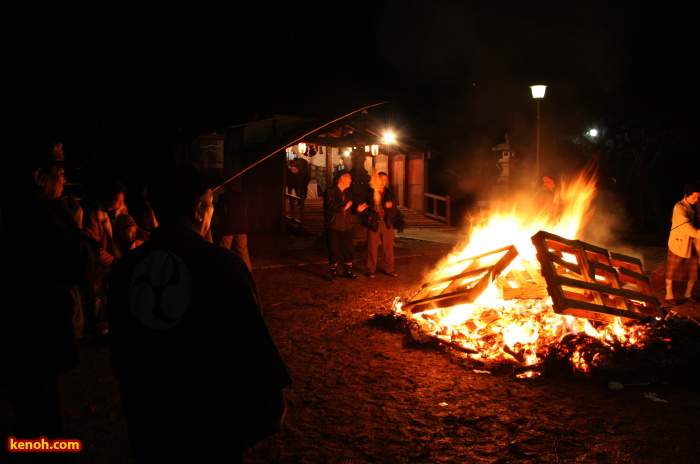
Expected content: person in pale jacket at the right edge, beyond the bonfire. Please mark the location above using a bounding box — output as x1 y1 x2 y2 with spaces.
666 182 700 306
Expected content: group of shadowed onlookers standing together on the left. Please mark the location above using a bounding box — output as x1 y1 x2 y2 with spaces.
0 141 291 462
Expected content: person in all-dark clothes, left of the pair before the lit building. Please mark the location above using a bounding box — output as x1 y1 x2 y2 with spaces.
323 172 358 280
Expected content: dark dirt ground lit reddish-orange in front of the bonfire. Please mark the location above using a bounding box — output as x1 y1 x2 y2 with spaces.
0 237 700 464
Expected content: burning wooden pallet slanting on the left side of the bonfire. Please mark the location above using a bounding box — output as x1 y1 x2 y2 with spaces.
403 245 518 314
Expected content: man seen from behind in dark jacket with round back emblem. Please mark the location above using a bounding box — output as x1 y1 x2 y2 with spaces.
107 166 291 463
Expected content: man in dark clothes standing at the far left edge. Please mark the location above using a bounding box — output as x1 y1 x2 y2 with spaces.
0 138 97 448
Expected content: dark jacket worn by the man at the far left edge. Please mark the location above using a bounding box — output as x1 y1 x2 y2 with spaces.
0 194 97 382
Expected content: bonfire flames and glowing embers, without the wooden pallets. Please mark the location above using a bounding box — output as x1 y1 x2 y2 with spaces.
395 171 660 375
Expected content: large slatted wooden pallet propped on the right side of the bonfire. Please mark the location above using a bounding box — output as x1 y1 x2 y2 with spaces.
532 231 663 322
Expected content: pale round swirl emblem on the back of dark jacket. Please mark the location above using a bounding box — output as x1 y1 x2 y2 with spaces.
131 251 192 330
